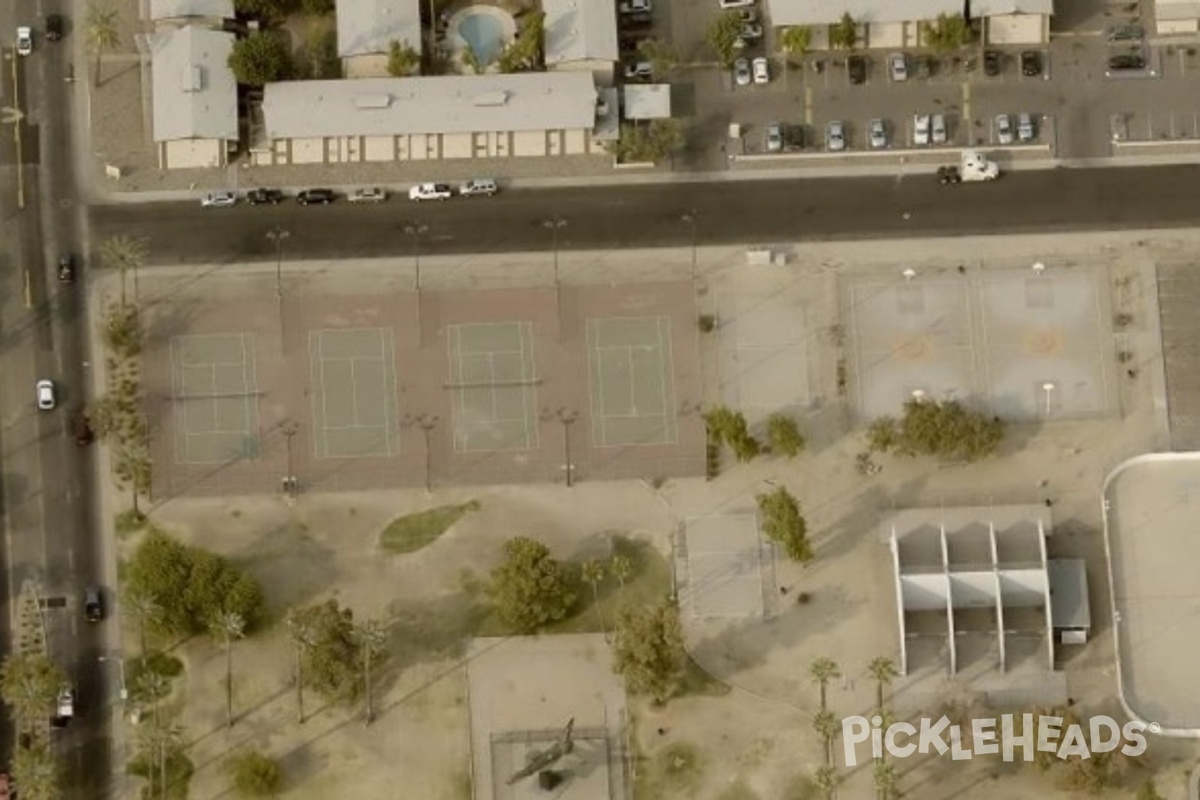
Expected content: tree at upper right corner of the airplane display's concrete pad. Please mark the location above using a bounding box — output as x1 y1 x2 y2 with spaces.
612 601 688 704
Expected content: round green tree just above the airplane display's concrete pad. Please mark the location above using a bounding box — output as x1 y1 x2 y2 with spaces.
488 536 576 633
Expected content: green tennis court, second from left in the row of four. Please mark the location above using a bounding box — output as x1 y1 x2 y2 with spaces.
308 327 398 458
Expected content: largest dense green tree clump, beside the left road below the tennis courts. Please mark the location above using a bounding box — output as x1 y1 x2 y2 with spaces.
126 530 263 636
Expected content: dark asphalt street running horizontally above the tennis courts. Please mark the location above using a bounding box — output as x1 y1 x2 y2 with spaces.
91 166 1200 264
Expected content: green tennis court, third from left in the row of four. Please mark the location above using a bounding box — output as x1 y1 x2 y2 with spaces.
446 323 539 451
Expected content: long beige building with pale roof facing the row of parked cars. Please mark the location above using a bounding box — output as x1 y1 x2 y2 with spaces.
251 72 604 164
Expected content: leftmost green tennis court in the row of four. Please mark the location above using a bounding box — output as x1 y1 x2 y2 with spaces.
170 333 259 464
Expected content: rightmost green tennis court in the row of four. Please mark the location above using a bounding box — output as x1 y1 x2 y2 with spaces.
588 317 678 446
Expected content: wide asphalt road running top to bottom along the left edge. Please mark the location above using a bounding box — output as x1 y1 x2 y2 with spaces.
0 0 112 798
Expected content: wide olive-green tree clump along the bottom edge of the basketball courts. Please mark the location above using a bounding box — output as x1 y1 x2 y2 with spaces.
866 398 1004 462
